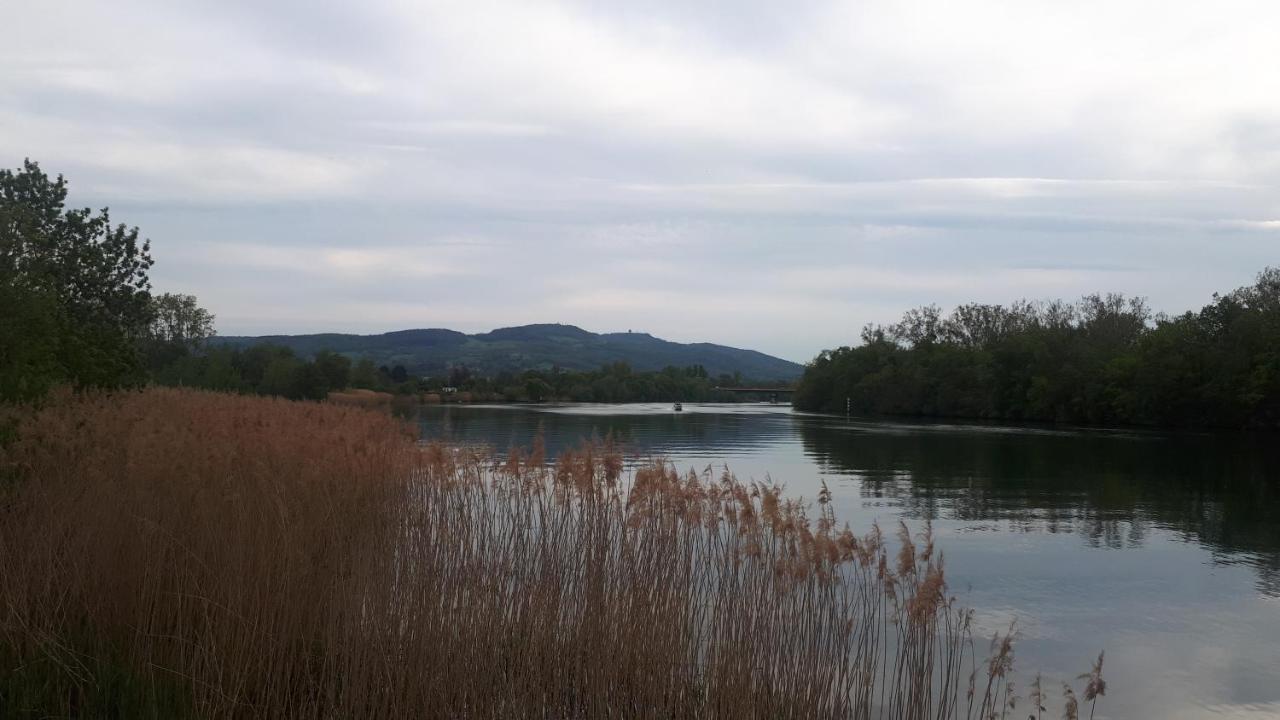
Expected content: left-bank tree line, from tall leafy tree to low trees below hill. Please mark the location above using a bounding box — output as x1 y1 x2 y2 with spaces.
0 160 768 402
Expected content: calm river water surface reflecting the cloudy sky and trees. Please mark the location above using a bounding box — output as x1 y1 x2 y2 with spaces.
419 405 1280 719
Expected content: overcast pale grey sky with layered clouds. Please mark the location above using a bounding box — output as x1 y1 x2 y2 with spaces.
0 0 1280 361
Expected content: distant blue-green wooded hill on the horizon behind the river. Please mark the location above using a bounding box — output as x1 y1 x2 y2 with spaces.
216 324 804 380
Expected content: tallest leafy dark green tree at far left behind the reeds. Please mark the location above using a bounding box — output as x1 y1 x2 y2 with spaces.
0 160 151 400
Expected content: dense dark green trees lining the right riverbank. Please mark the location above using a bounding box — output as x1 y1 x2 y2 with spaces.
795 268 1280 428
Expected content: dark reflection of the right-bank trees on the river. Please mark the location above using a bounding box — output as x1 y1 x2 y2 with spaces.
801 421 1280 594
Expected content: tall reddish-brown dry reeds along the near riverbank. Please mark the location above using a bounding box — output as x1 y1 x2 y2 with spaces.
0 389 1105 720
